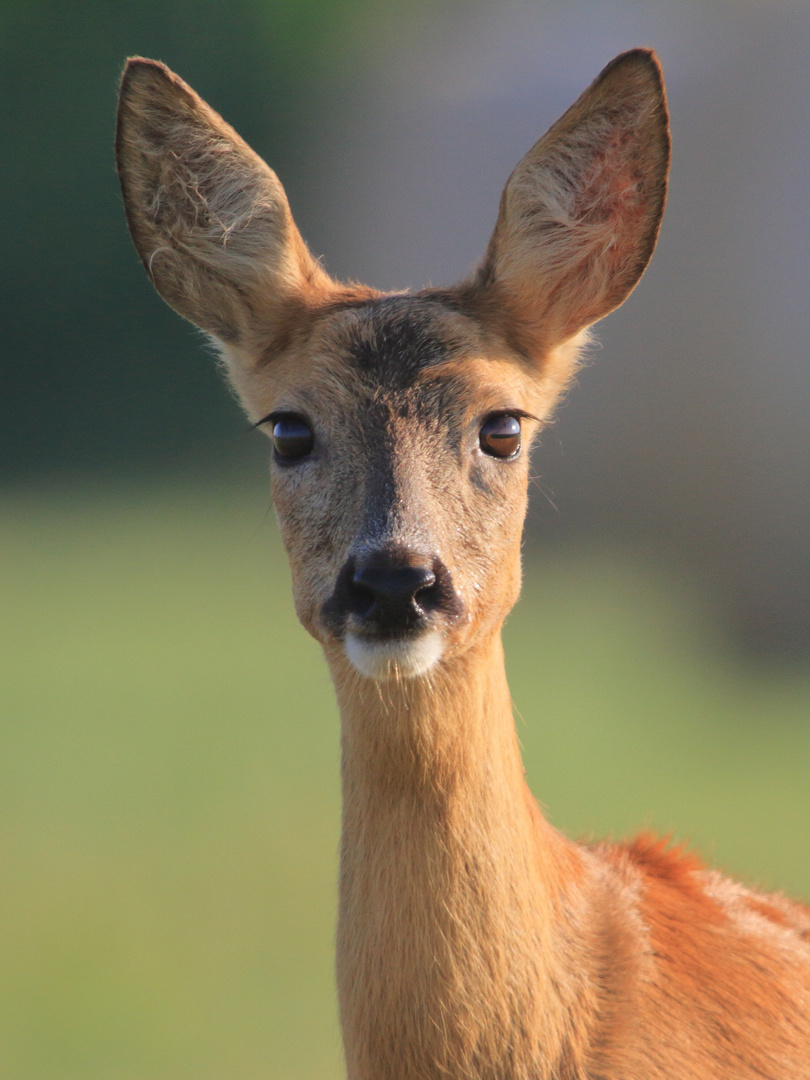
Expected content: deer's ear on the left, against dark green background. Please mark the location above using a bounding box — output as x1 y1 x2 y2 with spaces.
116 57 329 346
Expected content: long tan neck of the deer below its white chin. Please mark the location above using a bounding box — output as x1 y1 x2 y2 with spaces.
332 635 600 1080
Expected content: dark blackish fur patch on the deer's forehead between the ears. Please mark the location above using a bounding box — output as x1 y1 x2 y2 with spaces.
330 295 465 392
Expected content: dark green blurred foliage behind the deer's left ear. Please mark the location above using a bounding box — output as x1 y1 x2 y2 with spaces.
0 0 427 480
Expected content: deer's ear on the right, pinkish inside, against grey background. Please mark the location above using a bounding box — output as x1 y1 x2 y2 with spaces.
468 49 670 355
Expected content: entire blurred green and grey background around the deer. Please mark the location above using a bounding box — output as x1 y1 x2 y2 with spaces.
0 0 810 1080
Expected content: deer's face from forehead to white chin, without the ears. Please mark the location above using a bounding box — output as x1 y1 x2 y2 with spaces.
237 294 542 677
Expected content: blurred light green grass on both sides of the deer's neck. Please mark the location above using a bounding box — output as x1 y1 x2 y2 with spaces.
0 481 810 1080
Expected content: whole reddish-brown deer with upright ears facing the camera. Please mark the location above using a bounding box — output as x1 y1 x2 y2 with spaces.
117 49 810 1080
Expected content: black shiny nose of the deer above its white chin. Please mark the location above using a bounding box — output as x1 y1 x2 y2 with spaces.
324 548 459 635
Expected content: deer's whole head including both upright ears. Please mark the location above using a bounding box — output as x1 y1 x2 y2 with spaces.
117 51 669 678
